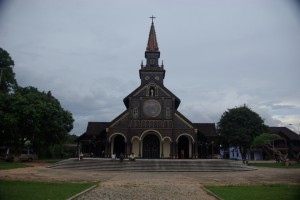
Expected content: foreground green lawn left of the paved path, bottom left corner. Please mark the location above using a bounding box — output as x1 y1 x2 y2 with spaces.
0 180 95 200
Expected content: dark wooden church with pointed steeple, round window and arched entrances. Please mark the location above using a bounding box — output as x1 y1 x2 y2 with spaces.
77 20 218 159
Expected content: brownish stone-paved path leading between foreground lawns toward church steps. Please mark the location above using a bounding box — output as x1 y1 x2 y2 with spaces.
75 172 216 200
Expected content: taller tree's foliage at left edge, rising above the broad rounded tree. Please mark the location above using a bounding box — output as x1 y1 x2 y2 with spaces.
0 48 17 94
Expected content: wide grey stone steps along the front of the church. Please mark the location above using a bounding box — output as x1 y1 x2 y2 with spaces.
49 158 255 172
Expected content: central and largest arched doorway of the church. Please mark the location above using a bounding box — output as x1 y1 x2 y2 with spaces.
143 134 160 158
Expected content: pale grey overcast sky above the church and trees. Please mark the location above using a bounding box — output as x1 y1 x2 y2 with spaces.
0 0 300 135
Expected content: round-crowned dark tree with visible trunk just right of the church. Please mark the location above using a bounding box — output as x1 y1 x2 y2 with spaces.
218 105 266 160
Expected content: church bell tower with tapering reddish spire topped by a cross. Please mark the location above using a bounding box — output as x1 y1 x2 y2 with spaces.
140 16 165 85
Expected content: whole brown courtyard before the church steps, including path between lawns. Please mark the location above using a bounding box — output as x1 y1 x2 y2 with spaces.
0 163 300 200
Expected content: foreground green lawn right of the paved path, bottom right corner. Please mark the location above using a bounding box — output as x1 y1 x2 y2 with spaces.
206 185 300 200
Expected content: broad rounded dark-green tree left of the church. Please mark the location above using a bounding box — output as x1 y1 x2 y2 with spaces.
3 87 74 155
